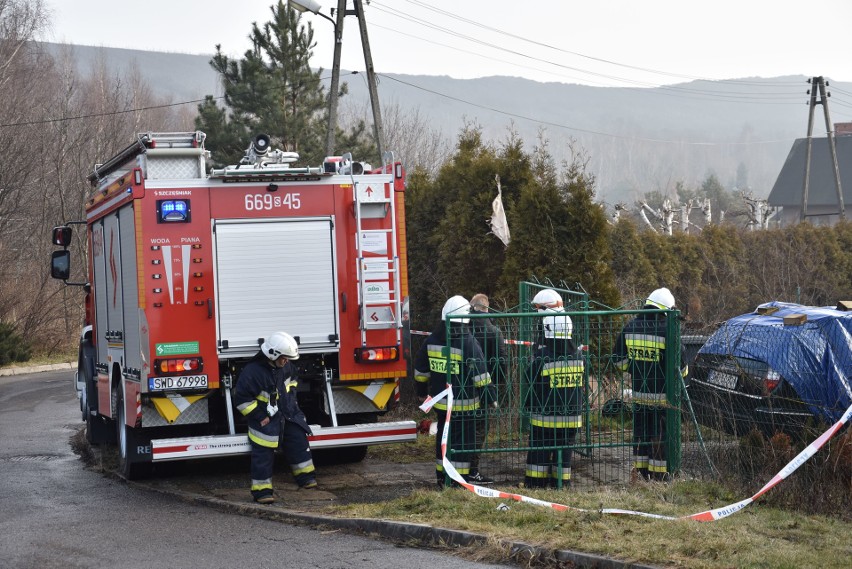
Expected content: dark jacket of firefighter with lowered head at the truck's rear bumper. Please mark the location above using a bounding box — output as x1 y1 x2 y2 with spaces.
234 353 311 448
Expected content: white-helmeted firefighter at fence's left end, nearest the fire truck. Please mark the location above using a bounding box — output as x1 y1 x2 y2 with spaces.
414 296 491 488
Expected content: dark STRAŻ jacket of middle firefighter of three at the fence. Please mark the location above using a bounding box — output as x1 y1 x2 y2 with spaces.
526 339 585 418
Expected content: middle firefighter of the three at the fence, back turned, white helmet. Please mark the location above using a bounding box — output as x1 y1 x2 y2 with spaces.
524 311 585 488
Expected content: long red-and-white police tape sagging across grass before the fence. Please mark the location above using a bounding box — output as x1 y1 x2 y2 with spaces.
420 385 852 522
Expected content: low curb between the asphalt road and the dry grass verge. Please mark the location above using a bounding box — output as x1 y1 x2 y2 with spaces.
135 482 656 569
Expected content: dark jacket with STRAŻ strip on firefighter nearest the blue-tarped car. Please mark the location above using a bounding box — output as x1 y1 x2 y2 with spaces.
614 306 687 407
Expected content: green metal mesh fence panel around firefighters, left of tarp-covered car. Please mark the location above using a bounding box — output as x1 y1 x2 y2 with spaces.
430 306 682 488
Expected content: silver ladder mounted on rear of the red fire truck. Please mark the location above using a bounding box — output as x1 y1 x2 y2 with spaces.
350 152 402 346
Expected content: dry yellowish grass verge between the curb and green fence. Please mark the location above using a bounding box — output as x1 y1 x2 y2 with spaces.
328 446 852 569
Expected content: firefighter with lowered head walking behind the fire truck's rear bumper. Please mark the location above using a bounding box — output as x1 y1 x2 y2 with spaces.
234 332 317 504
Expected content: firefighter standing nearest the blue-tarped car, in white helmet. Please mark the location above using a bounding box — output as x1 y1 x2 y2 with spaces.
615 288 688 480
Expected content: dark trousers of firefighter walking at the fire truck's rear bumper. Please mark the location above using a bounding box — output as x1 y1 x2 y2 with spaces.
251 421 315 500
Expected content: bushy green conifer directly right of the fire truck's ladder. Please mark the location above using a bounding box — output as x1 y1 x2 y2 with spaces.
406 125 532 326
